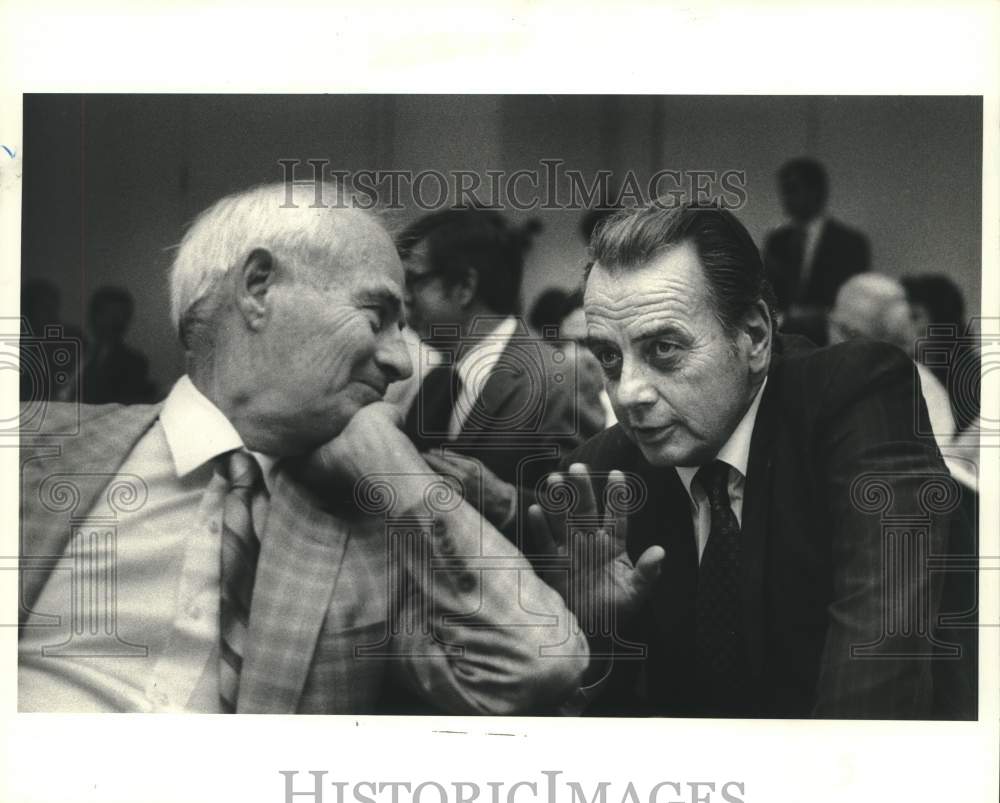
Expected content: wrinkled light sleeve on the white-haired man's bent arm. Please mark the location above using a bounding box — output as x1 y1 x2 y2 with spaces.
388 484 589 715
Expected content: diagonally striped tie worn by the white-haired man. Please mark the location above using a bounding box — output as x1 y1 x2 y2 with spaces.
217 450 262 714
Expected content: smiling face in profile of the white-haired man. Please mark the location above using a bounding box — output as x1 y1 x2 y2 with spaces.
260 219 411 454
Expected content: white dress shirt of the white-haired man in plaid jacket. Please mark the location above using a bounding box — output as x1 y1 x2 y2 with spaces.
18 376 275 713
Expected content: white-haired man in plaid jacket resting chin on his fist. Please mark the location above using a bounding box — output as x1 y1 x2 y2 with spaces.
19 185 588 714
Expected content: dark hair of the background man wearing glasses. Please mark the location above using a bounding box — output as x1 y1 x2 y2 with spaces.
396 209 541 315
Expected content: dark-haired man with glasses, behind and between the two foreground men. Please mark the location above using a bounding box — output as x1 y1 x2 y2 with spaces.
397 209 600 532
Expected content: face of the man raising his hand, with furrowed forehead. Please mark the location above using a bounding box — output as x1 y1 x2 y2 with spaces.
584 243 770 466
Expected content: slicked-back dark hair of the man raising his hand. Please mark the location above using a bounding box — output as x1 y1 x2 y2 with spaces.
587 201 775 335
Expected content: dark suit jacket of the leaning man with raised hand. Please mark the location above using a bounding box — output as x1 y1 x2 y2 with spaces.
565 338 974 718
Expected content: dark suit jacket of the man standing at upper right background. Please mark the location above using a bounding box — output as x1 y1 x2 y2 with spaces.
764 218 870 310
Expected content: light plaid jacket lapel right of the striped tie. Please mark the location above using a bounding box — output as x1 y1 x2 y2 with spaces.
237 471 349 714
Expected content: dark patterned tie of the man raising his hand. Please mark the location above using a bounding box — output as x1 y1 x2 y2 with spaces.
695 460 747 713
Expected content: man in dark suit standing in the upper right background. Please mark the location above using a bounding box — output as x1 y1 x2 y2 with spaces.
764 157 870 344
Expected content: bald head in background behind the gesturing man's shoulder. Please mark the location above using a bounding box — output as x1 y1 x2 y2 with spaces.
830 273 913 350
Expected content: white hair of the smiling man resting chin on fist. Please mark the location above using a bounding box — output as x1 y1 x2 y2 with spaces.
170 183 380 351
